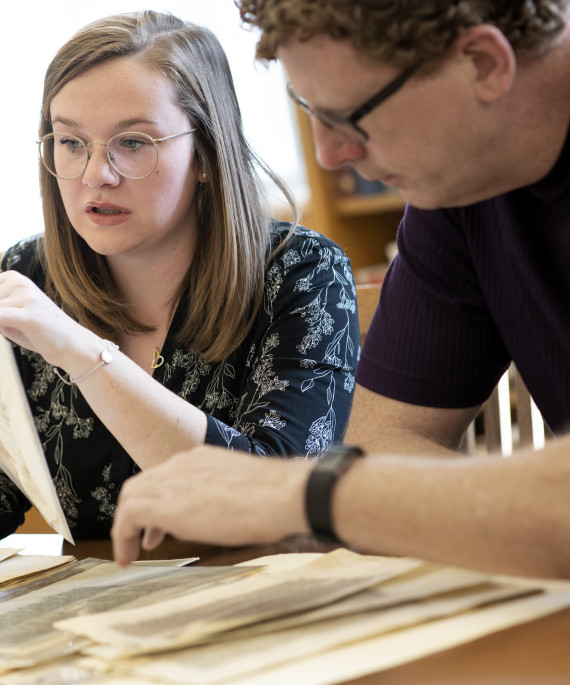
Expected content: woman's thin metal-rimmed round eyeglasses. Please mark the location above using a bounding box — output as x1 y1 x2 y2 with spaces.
37 128 196 181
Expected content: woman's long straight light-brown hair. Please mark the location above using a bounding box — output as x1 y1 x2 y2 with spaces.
40 11 296 361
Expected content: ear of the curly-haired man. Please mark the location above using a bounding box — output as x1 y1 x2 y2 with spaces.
452 24 517 103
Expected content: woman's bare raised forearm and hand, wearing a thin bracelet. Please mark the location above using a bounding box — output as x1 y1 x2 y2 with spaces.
0 271 207 469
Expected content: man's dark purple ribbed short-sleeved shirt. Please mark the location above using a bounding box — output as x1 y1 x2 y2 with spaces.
357 132 570 431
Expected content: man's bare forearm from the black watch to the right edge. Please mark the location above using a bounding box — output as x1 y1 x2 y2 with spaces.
333 440 570 576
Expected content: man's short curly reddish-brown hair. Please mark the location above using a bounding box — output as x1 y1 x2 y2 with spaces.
235 0 568 68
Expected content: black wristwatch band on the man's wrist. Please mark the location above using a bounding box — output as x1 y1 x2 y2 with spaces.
305 444 364 542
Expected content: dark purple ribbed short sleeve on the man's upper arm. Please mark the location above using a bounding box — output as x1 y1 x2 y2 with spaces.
357 206 509 408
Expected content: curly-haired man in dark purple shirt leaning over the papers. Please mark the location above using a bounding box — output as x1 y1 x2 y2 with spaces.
113 0 570 576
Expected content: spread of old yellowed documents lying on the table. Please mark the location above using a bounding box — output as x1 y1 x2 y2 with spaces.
0 549 570 685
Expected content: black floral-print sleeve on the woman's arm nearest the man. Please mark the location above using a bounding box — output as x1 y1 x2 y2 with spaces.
206 231 360 457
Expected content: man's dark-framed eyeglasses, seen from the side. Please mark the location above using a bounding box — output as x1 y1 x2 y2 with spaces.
287 64 419 143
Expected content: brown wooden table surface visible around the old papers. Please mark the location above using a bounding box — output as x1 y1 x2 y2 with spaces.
8 536 570 685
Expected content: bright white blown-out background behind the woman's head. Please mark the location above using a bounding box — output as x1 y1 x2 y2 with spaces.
0 0 307 251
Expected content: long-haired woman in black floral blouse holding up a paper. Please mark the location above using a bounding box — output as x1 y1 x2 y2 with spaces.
0 11 358 537
